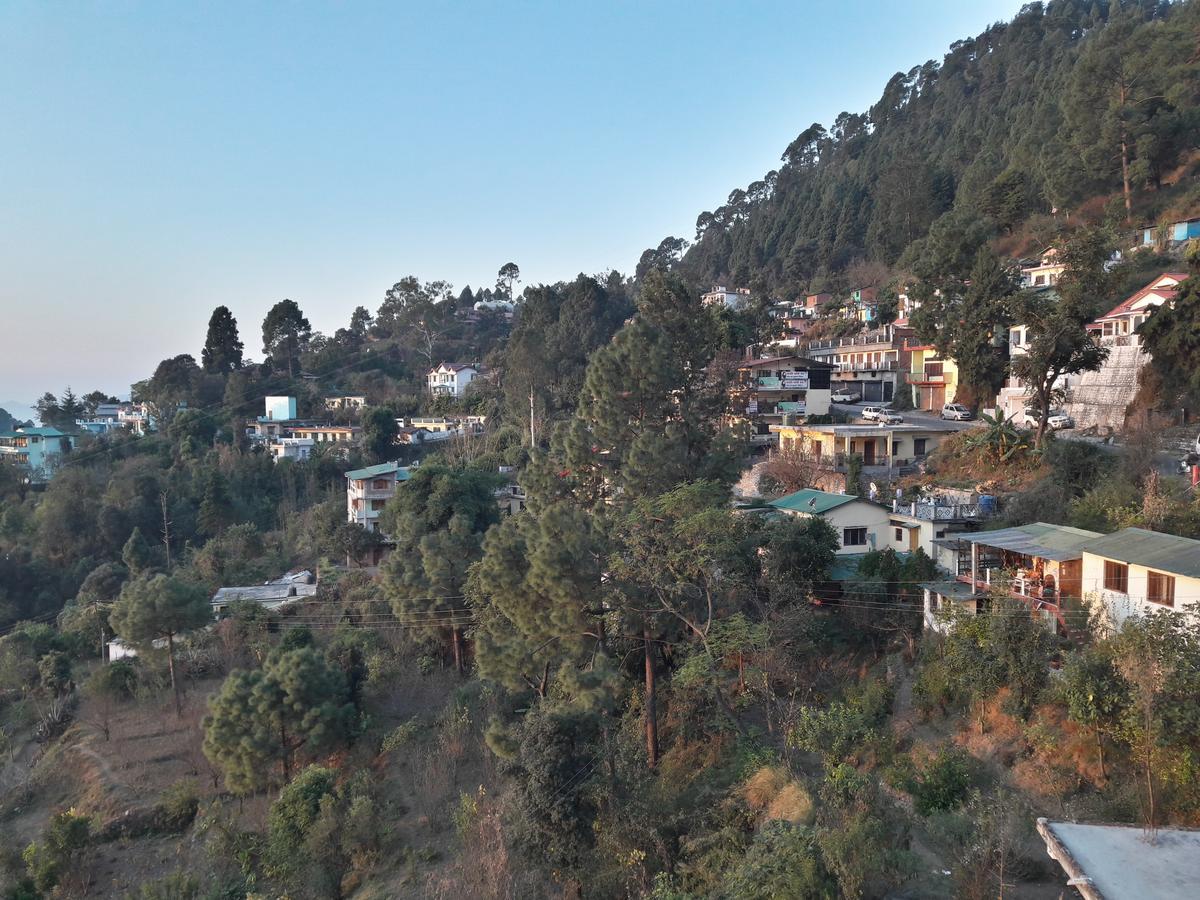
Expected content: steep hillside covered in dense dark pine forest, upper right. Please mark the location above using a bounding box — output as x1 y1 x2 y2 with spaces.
657 0 1200 293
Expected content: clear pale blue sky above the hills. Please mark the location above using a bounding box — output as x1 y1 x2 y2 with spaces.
0 0 1020 412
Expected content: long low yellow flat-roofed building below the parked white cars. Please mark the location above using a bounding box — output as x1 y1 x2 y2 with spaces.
770 424 955 468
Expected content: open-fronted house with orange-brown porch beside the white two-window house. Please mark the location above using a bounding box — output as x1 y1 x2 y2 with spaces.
922 522 1102 634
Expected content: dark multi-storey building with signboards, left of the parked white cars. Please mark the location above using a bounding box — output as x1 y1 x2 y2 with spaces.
730 356 832 445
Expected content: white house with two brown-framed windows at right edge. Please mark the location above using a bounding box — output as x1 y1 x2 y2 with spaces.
1082 528 1200 628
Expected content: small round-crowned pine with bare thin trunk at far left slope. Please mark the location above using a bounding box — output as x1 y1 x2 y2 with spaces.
109 575 212 715
